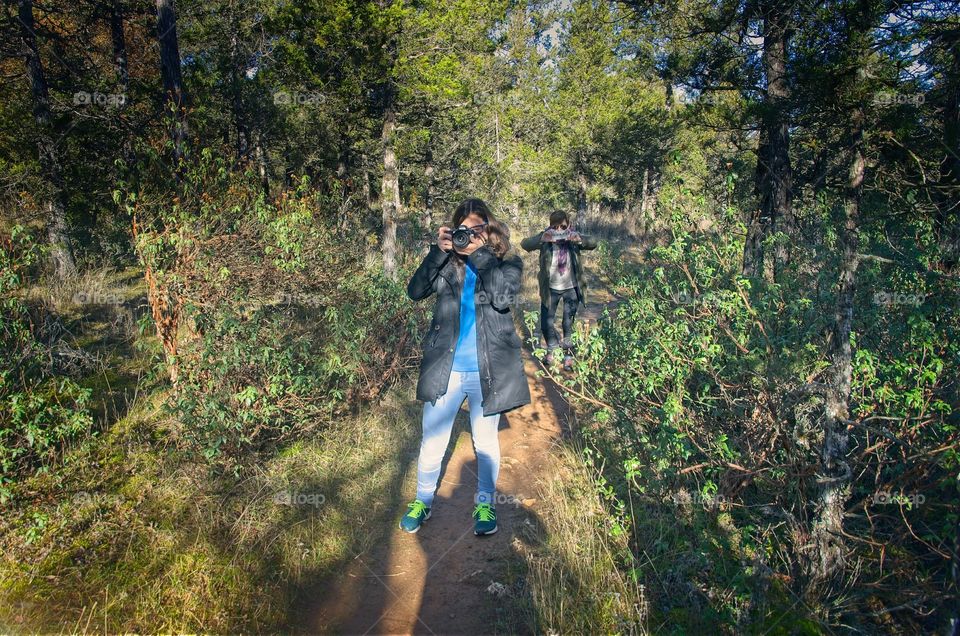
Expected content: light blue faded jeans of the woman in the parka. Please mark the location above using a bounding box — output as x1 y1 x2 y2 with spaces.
417 371 500 507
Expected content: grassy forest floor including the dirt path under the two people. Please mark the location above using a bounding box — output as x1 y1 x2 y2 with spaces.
0 241 632 634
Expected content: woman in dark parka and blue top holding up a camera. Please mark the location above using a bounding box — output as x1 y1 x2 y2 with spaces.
400 199 530 535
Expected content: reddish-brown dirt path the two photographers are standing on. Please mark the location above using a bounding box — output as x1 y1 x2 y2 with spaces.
296 242 632 634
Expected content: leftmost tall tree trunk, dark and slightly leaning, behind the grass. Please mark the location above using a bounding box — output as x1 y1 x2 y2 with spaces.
19 0 77 280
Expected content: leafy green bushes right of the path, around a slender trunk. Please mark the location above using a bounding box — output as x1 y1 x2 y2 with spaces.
566 215 960 628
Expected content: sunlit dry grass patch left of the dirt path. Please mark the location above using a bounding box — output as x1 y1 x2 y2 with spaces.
0 376 416 632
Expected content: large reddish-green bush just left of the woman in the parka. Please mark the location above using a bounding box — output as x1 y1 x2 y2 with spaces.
117 150 419 473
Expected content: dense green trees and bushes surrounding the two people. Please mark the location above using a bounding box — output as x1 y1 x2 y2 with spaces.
0 0 960 632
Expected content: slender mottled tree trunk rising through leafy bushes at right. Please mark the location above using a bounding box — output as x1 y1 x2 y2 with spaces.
812 107 866 580
